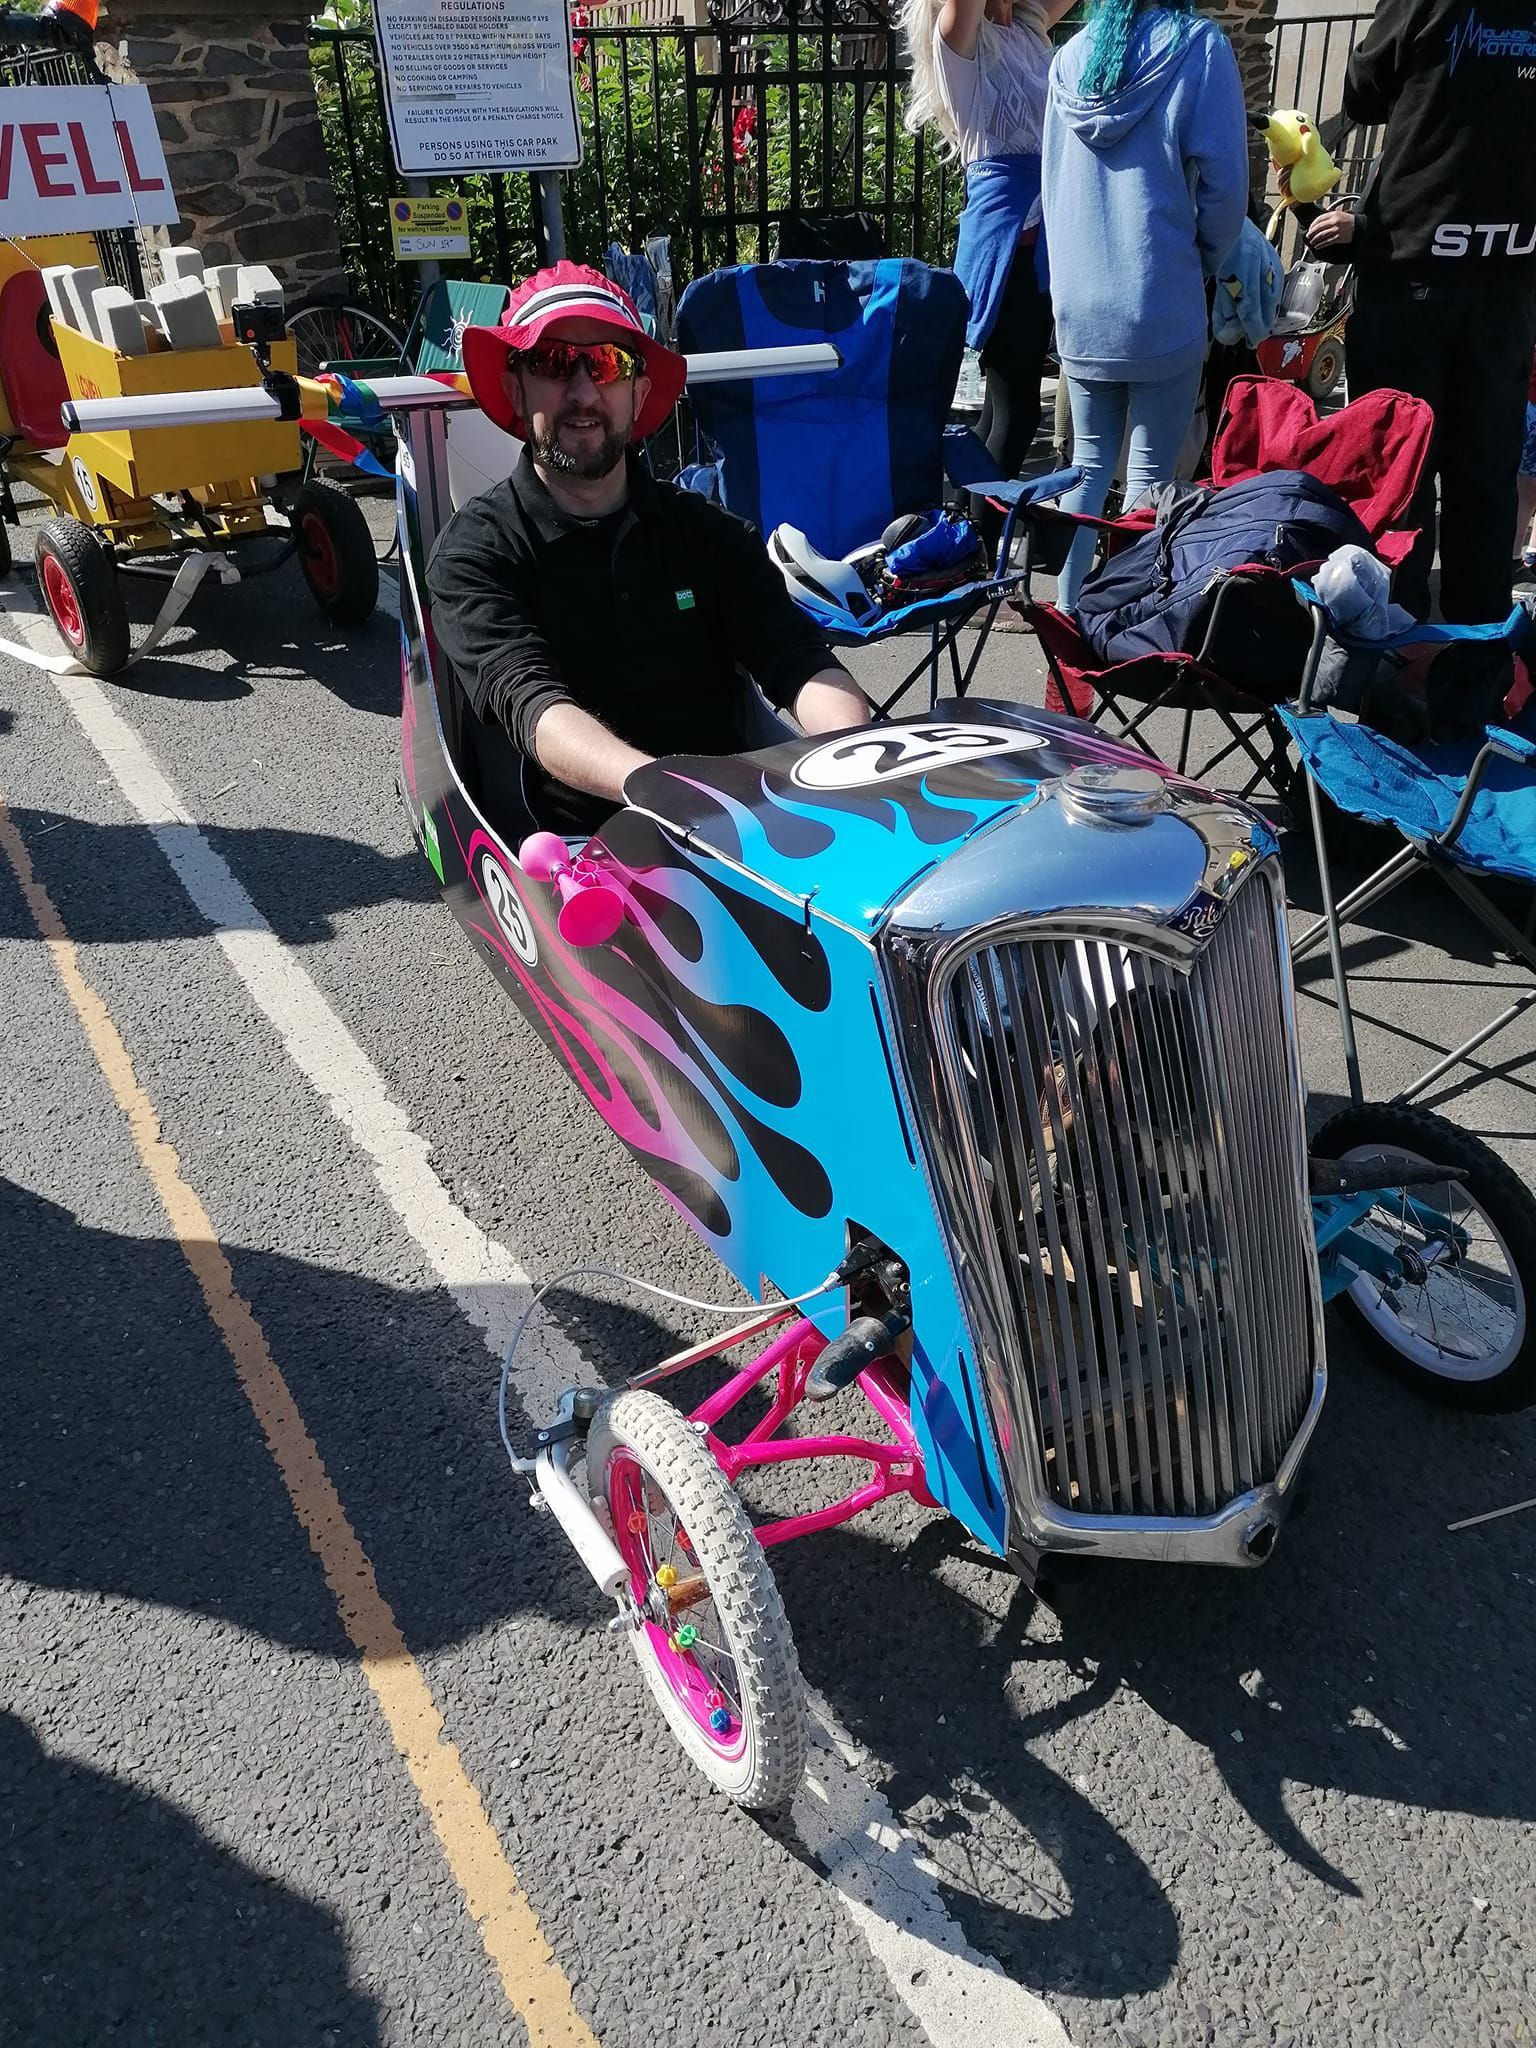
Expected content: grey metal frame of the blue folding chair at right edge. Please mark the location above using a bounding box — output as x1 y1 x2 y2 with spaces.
1290 602 1536 1104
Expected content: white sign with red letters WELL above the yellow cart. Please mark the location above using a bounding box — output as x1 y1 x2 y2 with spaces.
0 86 180 238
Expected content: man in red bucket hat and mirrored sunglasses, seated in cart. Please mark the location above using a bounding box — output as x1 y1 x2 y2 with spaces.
428 262 868 838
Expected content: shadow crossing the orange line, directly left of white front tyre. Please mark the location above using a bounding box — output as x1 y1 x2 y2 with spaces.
0 1178 594 1659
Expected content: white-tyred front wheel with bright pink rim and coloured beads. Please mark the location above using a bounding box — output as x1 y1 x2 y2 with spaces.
588 1391 805 1812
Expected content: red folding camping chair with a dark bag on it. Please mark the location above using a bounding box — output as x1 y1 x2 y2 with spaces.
1022 377 1434 797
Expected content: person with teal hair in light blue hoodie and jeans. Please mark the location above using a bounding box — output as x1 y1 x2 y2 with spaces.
1042 0 1247 610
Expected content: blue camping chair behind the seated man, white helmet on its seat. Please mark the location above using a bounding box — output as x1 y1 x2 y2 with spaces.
678 258 1077 711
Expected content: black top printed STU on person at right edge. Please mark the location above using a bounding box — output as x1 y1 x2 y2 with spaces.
1343 0 1536 283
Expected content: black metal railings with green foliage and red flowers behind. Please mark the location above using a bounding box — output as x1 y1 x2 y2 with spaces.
311 0 1374 317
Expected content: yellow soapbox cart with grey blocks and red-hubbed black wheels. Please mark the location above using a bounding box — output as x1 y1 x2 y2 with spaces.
0 233 379 676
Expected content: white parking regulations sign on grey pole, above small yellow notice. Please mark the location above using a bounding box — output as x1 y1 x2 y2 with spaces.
373 0 582 178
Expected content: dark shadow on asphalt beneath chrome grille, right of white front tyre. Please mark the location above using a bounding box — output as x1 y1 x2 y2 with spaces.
774 1325 1536 1999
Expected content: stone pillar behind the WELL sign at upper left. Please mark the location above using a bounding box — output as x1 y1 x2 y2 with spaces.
96 0 344 299
